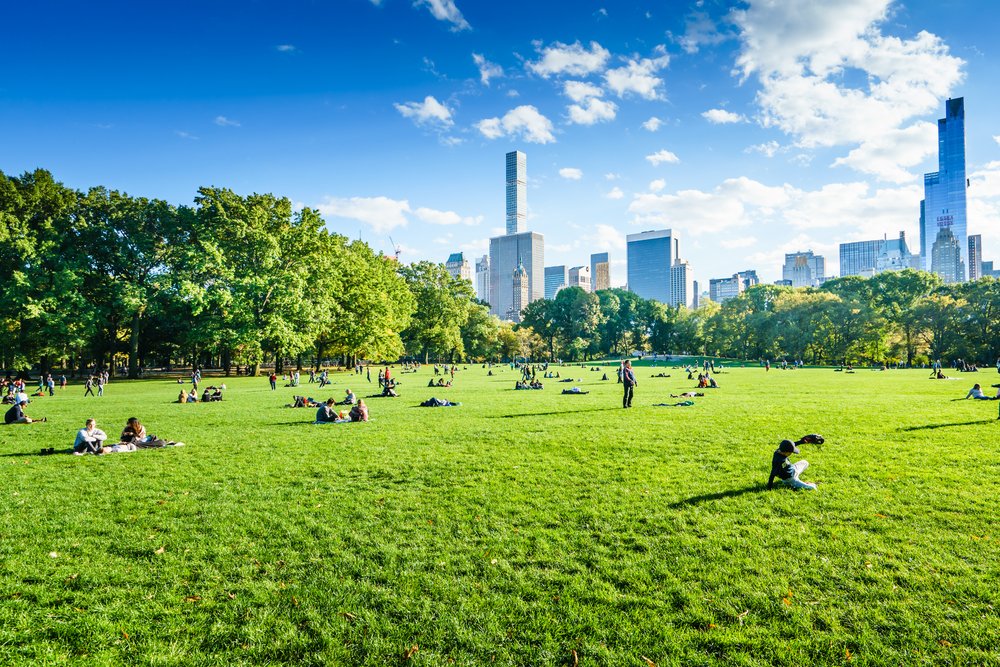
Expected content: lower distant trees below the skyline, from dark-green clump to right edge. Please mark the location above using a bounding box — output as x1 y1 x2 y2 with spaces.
523 269 1000 365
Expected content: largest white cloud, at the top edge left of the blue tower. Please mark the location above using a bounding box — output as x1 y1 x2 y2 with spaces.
731 0 965 181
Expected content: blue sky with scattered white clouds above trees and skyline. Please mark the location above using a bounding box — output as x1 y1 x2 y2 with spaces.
0 0 1000 285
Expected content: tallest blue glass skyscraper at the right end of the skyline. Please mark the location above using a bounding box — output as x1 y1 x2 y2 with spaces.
920 97 969 282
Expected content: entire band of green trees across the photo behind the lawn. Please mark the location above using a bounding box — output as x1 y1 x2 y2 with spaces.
0 169 1000 377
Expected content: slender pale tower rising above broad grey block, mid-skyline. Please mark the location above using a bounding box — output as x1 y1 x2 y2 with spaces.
489 151 545 317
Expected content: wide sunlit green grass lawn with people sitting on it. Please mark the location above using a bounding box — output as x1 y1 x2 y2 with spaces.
0 364 1000 667
